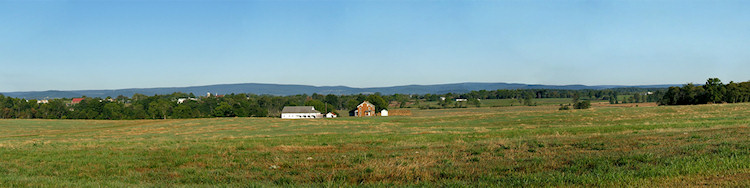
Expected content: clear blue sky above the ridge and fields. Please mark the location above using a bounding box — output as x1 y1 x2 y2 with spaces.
0 0 750 92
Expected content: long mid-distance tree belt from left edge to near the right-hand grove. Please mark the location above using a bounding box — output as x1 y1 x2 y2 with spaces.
0 88 661 120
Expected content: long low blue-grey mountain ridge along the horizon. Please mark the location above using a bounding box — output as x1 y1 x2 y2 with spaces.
1 82 679 99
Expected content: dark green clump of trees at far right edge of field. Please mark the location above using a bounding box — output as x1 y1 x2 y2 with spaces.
659 78 750 105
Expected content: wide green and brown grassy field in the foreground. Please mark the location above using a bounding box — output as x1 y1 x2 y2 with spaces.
0 104 750 187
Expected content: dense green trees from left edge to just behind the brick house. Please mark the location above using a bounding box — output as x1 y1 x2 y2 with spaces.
0 93 398 120
